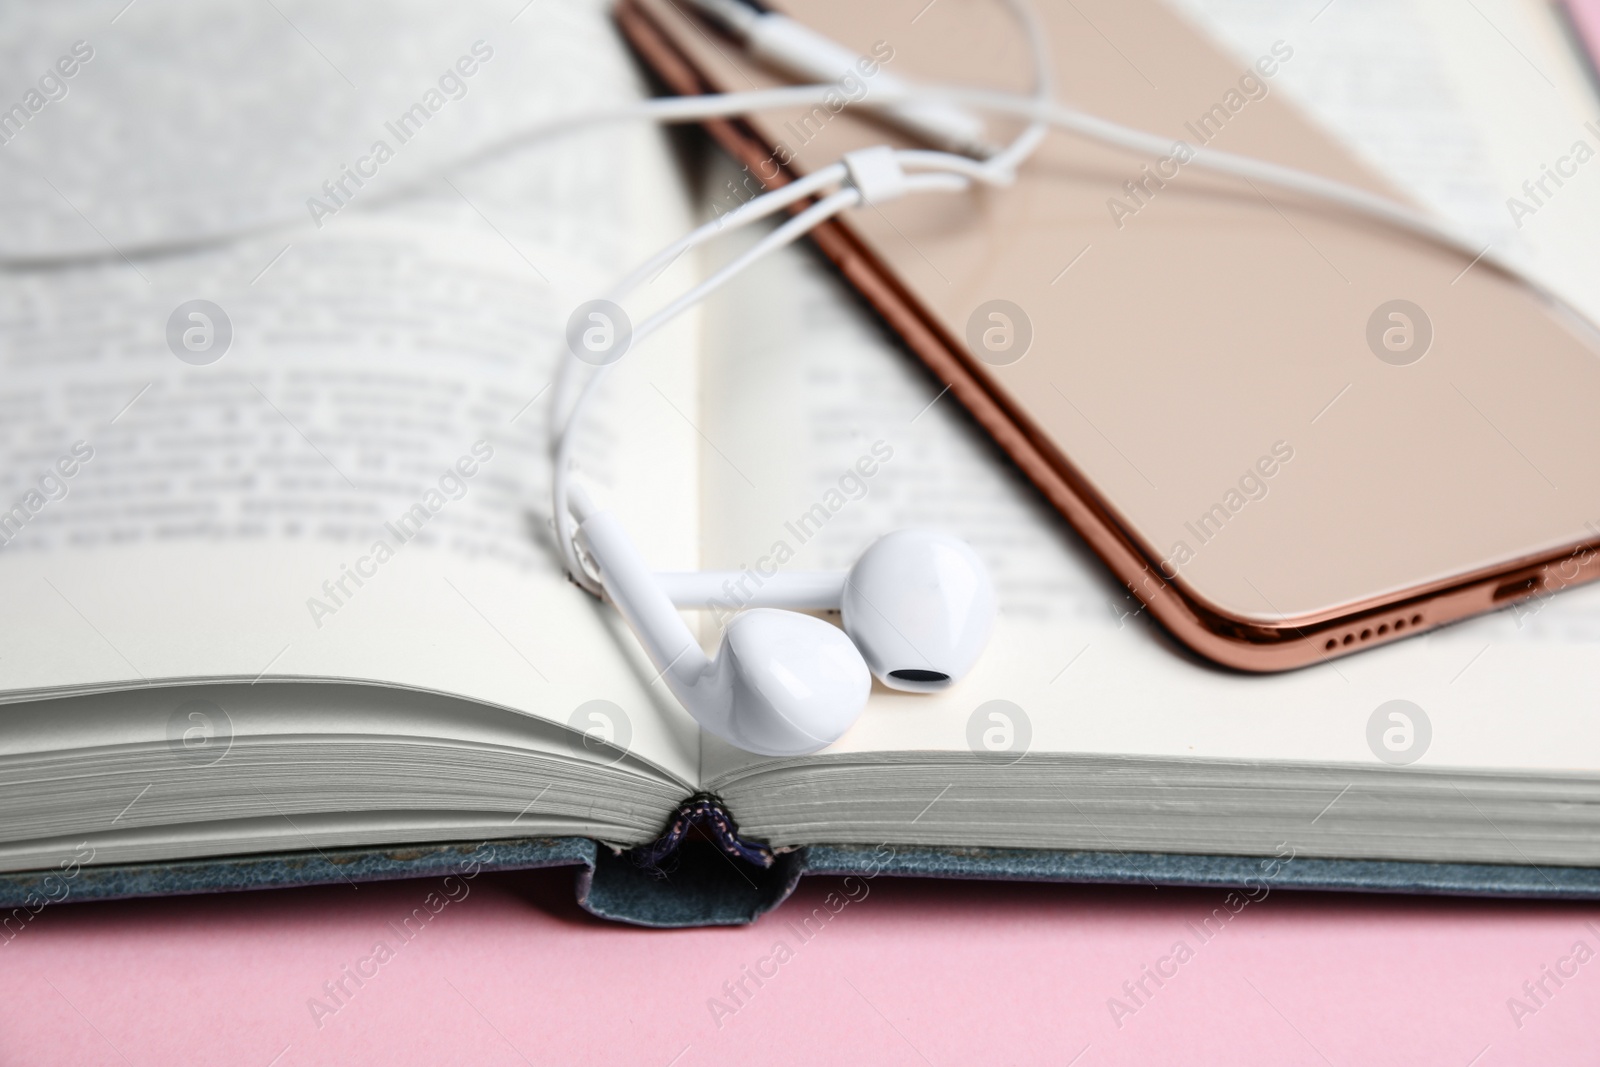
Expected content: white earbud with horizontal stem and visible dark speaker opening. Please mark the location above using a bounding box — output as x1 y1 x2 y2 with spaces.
658 530 995 693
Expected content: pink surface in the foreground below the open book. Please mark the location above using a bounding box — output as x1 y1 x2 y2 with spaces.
0 872 1600 1067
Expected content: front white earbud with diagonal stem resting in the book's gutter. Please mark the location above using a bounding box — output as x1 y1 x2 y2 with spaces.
570 486 872 755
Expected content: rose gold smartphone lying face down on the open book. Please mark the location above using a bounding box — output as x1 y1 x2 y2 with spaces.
618 0 1600 670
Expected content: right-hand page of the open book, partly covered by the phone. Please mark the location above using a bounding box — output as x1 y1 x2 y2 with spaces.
702 2 1600 784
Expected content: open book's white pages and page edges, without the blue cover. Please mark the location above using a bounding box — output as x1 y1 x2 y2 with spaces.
0 2 1600 908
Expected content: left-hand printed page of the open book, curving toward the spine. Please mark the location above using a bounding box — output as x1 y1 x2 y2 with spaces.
0 2 699 782
